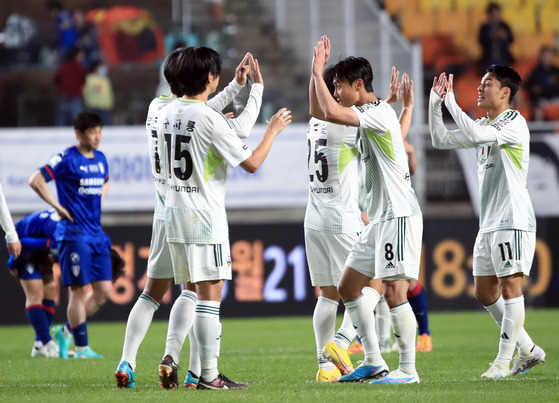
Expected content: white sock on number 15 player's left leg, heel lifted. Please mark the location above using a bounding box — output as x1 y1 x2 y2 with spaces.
163 290 197 364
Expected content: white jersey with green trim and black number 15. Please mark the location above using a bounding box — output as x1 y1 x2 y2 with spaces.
157 98 252 244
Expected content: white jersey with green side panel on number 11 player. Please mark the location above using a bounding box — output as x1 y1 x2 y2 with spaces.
476 109 536 232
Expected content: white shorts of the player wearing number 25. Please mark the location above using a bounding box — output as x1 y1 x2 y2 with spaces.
305 228 359 287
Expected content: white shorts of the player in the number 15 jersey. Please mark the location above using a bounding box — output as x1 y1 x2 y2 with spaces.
169 242 231 284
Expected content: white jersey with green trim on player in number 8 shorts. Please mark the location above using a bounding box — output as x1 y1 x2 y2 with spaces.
352 100 421 224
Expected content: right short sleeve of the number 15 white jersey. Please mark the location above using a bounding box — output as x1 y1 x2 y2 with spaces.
212 112 252 168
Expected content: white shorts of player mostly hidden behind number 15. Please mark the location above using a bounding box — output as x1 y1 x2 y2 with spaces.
147 217 174 279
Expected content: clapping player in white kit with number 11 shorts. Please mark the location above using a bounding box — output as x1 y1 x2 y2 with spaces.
429 65 545 379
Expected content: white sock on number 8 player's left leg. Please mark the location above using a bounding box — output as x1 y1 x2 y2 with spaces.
345 287 384 366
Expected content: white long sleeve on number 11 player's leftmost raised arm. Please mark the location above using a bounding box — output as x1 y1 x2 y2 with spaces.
429 90 475 150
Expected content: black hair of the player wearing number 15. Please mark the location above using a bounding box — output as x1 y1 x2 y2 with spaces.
177 46 221 96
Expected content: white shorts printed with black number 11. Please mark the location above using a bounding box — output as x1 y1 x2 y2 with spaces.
473 229 536 277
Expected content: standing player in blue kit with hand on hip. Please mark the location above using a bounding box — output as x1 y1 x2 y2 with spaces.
29 112 112 358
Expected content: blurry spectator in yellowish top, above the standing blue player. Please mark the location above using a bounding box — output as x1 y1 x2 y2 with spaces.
83 61 114 126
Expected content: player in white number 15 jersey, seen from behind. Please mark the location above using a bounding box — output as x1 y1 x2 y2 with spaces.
157 47 291 389
